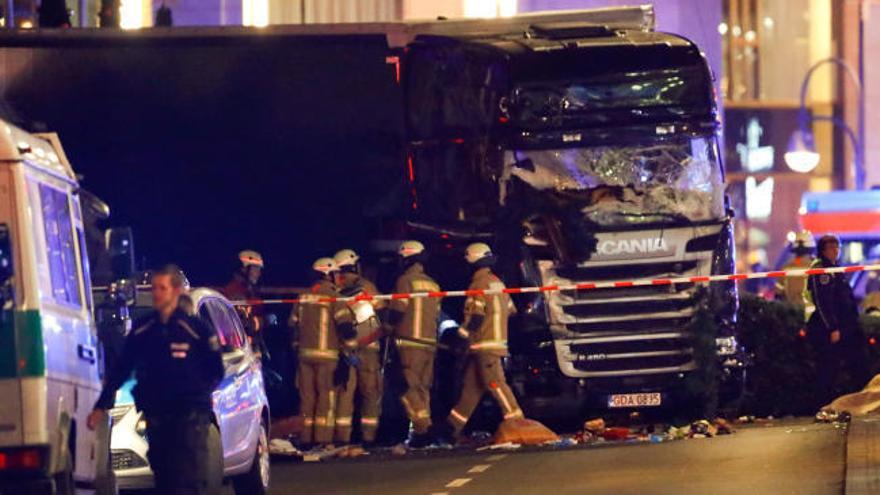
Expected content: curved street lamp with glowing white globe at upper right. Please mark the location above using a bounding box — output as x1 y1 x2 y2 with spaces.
785 57 865 189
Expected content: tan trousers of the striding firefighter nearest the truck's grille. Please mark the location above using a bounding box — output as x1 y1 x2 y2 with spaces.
448 352 523 435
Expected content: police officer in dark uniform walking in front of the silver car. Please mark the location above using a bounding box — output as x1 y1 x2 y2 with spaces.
87 266 223 494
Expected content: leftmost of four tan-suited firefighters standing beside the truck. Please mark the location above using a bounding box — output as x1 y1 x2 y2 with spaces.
291 258 357 448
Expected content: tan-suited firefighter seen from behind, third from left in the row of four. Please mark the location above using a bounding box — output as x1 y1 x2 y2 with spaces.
388 241 440 448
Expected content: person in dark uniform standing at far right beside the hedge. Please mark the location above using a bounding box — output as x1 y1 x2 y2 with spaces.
807 235 870 404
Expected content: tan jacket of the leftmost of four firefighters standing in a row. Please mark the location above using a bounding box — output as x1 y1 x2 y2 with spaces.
293 280 351 361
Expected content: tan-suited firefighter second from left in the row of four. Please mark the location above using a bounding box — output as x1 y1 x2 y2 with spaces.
333 249 385 444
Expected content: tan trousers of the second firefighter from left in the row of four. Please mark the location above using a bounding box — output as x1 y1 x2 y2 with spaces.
334 349 382 444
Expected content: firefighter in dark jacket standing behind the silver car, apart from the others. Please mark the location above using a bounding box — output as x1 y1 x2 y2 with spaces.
222 249 275 357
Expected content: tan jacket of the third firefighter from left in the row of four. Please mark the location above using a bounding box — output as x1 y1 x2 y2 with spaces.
391 263 440 348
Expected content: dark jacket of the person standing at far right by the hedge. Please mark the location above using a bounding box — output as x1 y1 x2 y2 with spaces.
807 257 859 335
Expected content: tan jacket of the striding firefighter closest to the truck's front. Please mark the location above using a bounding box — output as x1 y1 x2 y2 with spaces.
459 267 516 356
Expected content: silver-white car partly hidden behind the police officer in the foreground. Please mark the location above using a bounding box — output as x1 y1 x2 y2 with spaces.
103 289 269 495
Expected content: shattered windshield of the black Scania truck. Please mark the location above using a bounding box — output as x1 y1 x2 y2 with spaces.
500 136 724 226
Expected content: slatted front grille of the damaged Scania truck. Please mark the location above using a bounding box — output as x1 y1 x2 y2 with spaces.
538 225 712 378
